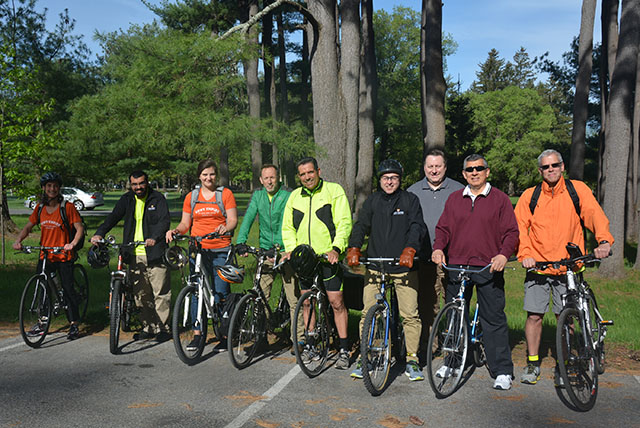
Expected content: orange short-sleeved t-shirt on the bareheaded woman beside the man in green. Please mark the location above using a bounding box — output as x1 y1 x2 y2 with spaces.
182 187 236 249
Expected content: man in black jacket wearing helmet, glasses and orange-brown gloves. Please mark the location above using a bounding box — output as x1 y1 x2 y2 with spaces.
347 159 427 381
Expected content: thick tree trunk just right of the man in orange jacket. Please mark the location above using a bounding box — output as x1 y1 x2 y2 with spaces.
601 0 640 277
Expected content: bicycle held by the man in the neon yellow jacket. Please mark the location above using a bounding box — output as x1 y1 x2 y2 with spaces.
291 250 338 378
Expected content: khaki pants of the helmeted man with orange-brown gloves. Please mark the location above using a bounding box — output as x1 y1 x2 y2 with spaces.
360 269 422 361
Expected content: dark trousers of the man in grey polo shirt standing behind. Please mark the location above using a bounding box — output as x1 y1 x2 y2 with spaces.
418 262 446 352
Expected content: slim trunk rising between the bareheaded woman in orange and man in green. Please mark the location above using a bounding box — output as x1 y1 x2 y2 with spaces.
245 0 262 190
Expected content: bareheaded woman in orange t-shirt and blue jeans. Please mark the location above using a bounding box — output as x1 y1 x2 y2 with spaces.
166 159 238 348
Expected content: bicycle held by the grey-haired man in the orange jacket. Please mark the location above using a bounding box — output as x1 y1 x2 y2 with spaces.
536 243 613 412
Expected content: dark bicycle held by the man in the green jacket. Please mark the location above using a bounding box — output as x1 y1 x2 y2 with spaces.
227 245 290 369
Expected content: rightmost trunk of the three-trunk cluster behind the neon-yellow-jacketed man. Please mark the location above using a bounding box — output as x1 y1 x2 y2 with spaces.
353 0 378 213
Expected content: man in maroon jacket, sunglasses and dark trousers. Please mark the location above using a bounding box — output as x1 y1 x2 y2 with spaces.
431 154 519 389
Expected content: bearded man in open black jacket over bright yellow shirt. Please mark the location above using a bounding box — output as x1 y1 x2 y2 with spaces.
91 170 171 341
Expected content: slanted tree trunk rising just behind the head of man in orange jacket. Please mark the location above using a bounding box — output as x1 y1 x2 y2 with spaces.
569 0 596 180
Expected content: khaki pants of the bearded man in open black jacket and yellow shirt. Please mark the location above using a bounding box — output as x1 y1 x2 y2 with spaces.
129 256 171 334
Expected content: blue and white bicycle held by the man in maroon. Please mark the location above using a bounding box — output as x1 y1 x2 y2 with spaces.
427 263 491 398
